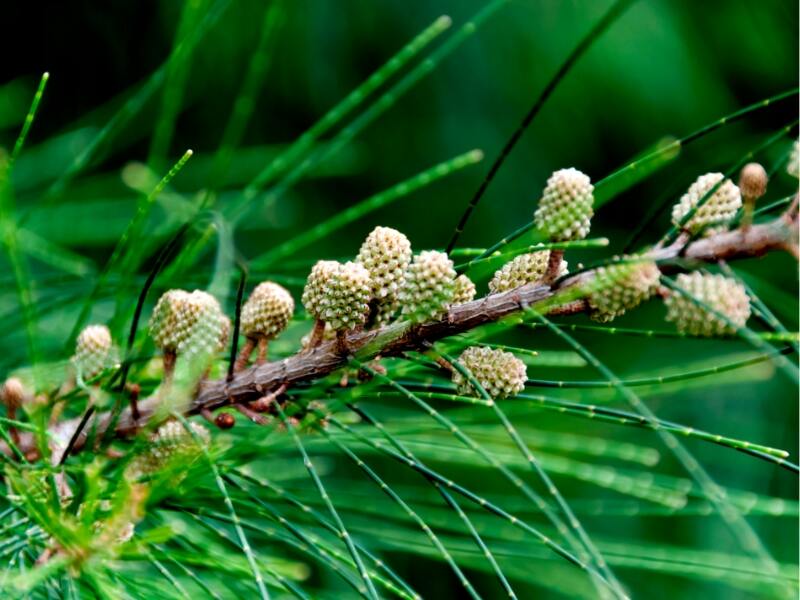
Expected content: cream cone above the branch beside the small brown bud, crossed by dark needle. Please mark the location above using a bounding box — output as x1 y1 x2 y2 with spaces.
672 173 742 234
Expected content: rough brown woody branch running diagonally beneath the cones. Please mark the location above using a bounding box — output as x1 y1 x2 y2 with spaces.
0 212 798 454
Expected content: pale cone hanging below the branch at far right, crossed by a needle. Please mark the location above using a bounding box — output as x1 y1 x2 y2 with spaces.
664 272 750 337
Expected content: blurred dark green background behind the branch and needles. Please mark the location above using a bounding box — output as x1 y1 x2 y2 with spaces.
0 0 798 598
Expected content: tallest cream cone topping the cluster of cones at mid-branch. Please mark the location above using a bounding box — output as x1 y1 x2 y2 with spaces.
356 227 411 301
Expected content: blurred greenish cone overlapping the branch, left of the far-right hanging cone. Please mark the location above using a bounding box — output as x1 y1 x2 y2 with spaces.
588 261 661 322
